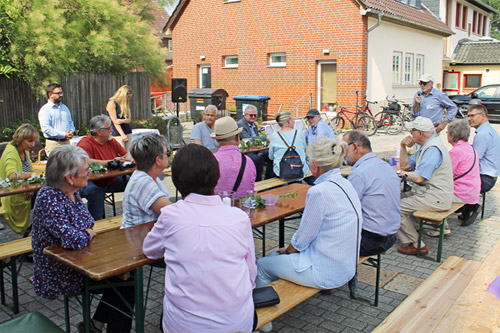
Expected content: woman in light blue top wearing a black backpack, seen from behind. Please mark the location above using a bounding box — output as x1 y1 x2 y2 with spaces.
269 112 309 181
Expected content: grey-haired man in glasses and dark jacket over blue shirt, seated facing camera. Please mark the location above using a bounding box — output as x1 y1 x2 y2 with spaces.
238 104 274 181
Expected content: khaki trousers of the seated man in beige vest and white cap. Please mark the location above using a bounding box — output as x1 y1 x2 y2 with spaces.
397 192 450 245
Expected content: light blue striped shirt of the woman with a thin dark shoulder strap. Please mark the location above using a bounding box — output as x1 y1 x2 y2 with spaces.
290 169 363 289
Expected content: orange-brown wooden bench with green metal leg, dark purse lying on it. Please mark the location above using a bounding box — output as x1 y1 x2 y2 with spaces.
257 254 380 329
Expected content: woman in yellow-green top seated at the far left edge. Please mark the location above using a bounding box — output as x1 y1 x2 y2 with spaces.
0 124 39 236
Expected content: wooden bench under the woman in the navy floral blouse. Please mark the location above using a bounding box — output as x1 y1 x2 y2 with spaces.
0 215 122 314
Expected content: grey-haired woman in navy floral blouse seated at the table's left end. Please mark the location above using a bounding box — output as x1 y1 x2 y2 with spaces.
32 145 134 332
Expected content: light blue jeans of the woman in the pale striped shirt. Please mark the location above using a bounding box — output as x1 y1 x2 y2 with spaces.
255 251 319 288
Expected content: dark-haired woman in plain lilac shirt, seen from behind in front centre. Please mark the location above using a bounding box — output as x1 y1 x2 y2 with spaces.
143 144 257 333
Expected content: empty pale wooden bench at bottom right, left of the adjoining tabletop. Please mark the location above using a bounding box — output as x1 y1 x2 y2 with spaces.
373 256 481 333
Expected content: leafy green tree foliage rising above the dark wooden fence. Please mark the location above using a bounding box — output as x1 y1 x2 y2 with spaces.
0 0 165 92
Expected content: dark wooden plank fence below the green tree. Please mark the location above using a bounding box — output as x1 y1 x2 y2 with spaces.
0 72 151 128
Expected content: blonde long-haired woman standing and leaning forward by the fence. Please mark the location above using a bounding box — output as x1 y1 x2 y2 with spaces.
106 85 132 151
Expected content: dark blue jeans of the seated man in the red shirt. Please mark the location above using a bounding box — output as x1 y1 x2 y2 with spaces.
78 176 130 221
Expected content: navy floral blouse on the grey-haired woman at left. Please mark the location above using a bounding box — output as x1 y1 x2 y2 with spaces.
31 185 94 299
